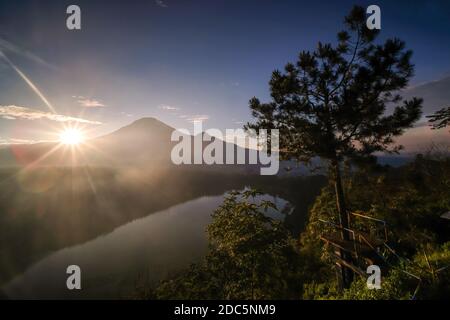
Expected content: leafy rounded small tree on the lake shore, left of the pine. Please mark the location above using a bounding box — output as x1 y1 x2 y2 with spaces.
207 190 298 299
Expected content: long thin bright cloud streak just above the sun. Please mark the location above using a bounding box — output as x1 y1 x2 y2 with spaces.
0 106 102 124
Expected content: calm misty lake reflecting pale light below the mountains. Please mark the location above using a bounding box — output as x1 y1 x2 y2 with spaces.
2 194 294 299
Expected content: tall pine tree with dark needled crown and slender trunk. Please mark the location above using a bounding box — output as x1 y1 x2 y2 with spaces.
245 6 422 287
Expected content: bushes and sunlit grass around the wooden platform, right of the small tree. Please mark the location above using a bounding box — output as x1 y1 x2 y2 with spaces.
301 154 450 299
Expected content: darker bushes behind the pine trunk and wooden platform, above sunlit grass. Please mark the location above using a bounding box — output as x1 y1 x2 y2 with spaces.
302 155 450 256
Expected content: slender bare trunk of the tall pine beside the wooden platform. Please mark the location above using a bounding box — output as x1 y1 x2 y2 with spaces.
332 160 353 288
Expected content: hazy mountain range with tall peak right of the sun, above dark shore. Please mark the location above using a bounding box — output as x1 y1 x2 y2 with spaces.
0 118 259 172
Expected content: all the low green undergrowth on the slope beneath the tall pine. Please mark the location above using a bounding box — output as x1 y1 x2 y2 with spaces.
151 155 450 300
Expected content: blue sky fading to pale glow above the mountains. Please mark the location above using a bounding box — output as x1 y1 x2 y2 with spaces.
0 0 450 143
